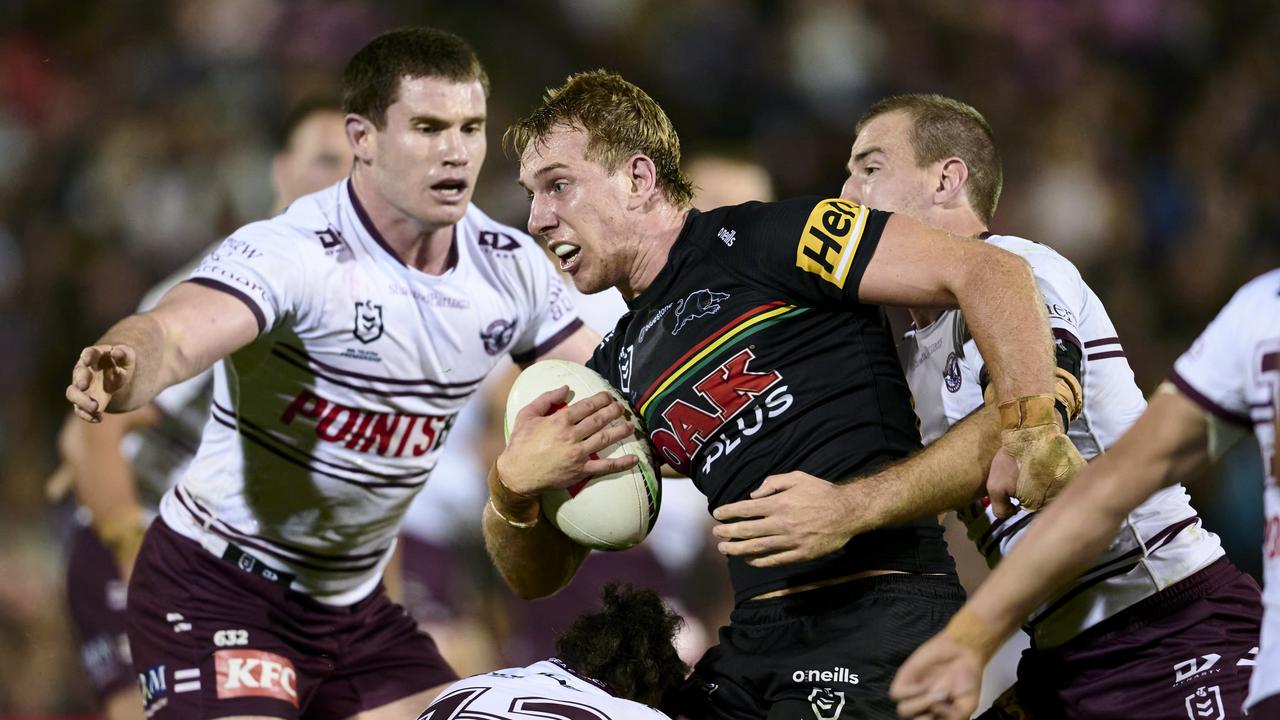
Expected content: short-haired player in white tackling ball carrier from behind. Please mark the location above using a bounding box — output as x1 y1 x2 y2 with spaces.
716 95 1258 719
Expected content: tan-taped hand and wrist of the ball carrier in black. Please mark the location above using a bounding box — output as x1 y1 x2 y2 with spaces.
987 395 1084 518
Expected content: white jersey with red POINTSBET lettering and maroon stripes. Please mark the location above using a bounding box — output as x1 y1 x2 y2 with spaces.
161 181 581 605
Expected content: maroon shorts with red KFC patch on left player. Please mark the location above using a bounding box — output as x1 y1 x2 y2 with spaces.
128 520 457 720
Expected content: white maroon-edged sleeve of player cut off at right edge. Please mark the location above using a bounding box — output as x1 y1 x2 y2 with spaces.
1169 278 1257 427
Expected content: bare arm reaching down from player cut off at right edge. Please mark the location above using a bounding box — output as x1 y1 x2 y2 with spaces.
890 386 1207 717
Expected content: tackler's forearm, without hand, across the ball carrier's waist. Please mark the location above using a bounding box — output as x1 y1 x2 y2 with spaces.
847 407 1000 534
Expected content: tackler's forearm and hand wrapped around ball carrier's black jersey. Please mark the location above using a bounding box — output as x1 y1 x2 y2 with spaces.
712 407 1000 568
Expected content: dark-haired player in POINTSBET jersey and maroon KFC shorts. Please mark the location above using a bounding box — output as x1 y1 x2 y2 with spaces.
67 28 611 720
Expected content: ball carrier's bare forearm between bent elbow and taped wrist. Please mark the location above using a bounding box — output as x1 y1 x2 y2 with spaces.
952 245 1055 404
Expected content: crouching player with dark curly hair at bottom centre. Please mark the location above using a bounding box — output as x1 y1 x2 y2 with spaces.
419 583 687 720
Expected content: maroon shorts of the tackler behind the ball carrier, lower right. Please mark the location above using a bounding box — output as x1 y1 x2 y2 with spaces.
1018 557 1262 720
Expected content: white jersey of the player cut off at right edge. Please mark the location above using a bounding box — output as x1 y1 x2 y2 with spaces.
1170 269 1280 707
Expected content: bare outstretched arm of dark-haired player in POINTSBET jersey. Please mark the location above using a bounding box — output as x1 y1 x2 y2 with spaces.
67 282 260 423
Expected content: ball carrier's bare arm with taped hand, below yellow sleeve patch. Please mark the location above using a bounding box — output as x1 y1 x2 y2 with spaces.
859 214 1084 518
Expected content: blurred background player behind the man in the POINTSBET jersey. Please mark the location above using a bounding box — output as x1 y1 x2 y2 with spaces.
59 97 351 720
